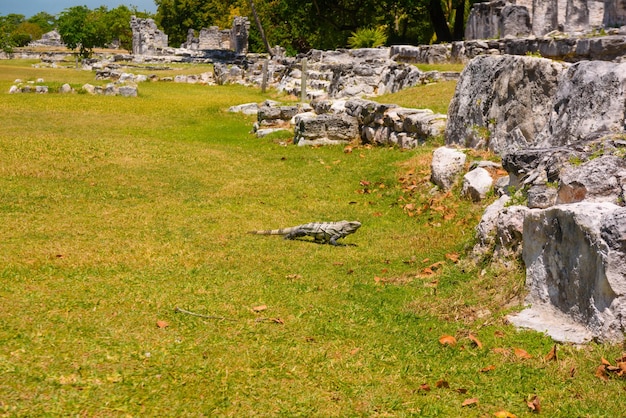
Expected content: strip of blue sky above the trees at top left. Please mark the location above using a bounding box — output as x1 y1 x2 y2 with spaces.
0 0 156 18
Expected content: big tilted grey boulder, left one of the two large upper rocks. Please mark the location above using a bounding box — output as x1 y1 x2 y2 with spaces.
446 55 566 154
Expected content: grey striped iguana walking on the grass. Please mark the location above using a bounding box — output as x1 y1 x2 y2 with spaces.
248 221 361 245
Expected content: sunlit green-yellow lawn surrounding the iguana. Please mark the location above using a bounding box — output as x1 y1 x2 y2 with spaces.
0 61 625 417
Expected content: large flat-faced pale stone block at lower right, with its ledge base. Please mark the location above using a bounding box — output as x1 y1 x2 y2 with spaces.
511 202 626 342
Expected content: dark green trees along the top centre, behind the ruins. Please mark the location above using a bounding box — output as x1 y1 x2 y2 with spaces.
155 0 476 54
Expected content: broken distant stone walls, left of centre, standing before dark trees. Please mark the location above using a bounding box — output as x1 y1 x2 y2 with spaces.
130 16 250 55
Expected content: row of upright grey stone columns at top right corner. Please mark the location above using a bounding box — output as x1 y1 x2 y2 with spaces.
465 0 626 40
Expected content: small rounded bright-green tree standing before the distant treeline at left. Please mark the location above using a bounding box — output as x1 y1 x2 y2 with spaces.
58 6 112 58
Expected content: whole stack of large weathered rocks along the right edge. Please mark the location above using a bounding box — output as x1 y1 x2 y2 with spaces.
446 56 626 342
